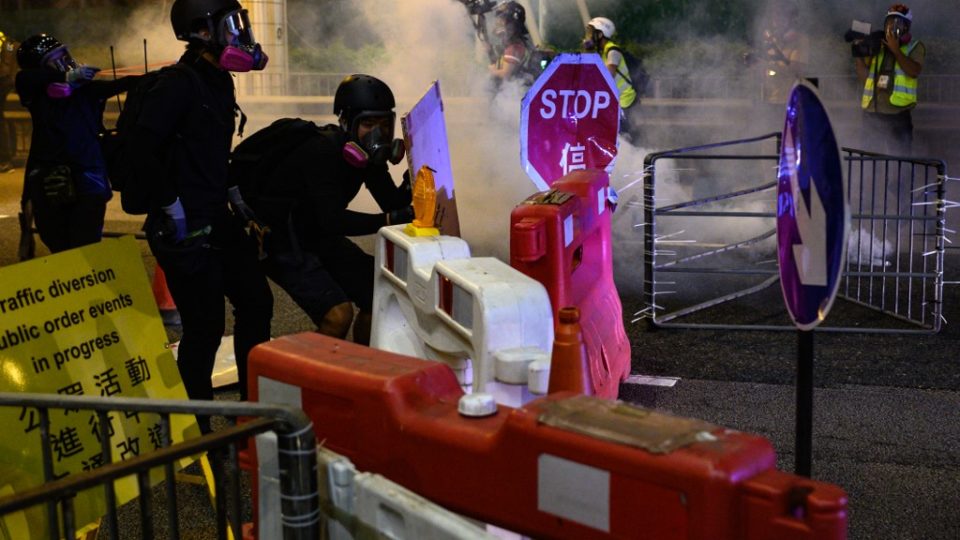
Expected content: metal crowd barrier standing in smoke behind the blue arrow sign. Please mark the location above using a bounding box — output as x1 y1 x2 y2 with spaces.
636 133 948 333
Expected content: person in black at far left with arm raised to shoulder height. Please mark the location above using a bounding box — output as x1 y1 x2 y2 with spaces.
16 34 136 253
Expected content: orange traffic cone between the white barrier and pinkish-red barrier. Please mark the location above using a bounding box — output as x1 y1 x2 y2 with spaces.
550 307 593 396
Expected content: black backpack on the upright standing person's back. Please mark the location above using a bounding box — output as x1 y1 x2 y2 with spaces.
100 64 200 214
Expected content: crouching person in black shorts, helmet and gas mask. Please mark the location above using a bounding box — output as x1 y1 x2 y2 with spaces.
231 75 413 344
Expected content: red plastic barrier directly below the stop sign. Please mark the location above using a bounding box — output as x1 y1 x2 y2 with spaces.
510 169 630 399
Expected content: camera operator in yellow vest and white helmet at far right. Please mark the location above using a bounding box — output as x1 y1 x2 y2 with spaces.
853 4 926 155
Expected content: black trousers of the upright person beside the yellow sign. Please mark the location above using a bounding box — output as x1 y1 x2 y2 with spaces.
146 216 273 412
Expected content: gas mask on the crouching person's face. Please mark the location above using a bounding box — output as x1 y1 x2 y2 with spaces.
343 111 406 169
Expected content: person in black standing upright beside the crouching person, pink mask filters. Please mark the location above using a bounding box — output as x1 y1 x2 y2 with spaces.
124 0 273 422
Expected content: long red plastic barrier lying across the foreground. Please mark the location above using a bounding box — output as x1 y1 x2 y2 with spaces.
249 333 847 540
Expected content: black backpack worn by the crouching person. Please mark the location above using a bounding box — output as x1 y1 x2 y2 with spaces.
230 118 326 220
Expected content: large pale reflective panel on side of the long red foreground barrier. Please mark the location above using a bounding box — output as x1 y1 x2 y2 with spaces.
537 454 610 533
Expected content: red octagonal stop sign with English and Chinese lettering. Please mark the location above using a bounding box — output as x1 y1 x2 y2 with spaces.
520 53 620 190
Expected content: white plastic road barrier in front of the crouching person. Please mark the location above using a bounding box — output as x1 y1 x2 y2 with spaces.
370 225 553 406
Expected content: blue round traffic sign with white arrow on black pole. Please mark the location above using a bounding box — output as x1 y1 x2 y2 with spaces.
777 83 850 330
